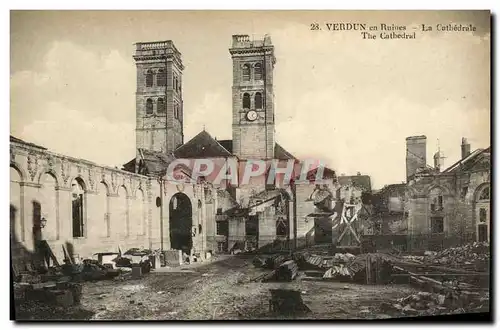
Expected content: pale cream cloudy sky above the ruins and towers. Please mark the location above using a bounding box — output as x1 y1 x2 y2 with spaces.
10 11 490 188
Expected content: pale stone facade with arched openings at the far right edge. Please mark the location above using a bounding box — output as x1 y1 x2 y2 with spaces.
407 135 491 245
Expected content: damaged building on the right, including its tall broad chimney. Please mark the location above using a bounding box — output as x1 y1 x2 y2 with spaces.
372 136 491 250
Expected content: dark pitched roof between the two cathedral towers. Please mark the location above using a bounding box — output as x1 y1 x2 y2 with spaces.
174 130 231 158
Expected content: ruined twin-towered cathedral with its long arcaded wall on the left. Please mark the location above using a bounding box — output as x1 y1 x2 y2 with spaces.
10 35 361 268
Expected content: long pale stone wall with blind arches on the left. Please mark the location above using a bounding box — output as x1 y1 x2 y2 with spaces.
10 142 155 261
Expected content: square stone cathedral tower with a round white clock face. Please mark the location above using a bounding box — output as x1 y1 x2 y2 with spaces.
229 35 276 160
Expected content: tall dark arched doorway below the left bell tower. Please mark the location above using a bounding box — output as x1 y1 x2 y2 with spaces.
169 193 193 254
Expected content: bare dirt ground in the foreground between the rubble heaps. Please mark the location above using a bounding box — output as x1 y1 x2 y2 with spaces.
13 256 490 320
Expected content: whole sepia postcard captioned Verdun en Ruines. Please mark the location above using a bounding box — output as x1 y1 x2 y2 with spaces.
10 11 492 321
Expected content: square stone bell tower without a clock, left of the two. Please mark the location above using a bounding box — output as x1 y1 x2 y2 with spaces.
134 40 184 160
